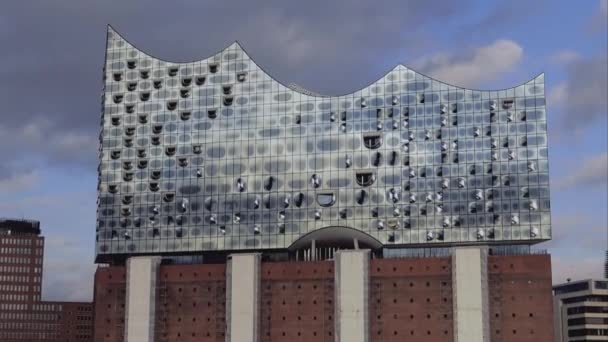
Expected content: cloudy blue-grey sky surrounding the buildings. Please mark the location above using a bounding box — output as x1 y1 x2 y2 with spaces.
0 0 608 300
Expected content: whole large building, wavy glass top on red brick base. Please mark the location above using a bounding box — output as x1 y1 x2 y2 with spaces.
95 28 553 342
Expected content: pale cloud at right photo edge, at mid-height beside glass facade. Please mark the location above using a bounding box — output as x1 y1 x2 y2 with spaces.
556 153 608 190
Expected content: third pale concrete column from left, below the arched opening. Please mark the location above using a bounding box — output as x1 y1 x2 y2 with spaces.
334 250 370 342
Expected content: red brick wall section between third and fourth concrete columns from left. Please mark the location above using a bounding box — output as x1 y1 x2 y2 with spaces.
369 258 453 342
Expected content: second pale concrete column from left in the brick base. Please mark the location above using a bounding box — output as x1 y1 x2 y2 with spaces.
226 253 260 342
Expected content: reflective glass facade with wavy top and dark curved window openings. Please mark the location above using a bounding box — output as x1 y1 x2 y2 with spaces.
96 29 551 257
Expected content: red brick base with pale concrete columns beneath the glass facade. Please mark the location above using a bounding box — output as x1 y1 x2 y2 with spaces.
94 248 553 342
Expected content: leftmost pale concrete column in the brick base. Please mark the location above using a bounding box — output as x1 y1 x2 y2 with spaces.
125 256 161 342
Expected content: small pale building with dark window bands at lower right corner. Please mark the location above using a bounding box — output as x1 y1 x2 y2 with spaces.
553 279 608 342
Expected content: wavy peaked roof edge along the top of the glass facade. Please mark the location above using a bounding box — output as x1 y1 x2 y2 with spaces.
106 24 545 98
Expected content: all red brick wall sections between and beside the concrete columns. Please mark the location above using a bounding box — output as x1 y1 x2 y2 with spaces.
94 255 553 342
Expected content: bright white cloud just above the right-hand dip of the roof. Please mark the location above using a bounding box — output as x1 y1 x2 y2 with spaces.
414 39 524 87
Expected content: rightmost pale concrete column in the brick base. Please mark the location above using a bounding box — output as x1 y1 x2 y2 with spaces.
452 247 490 342
